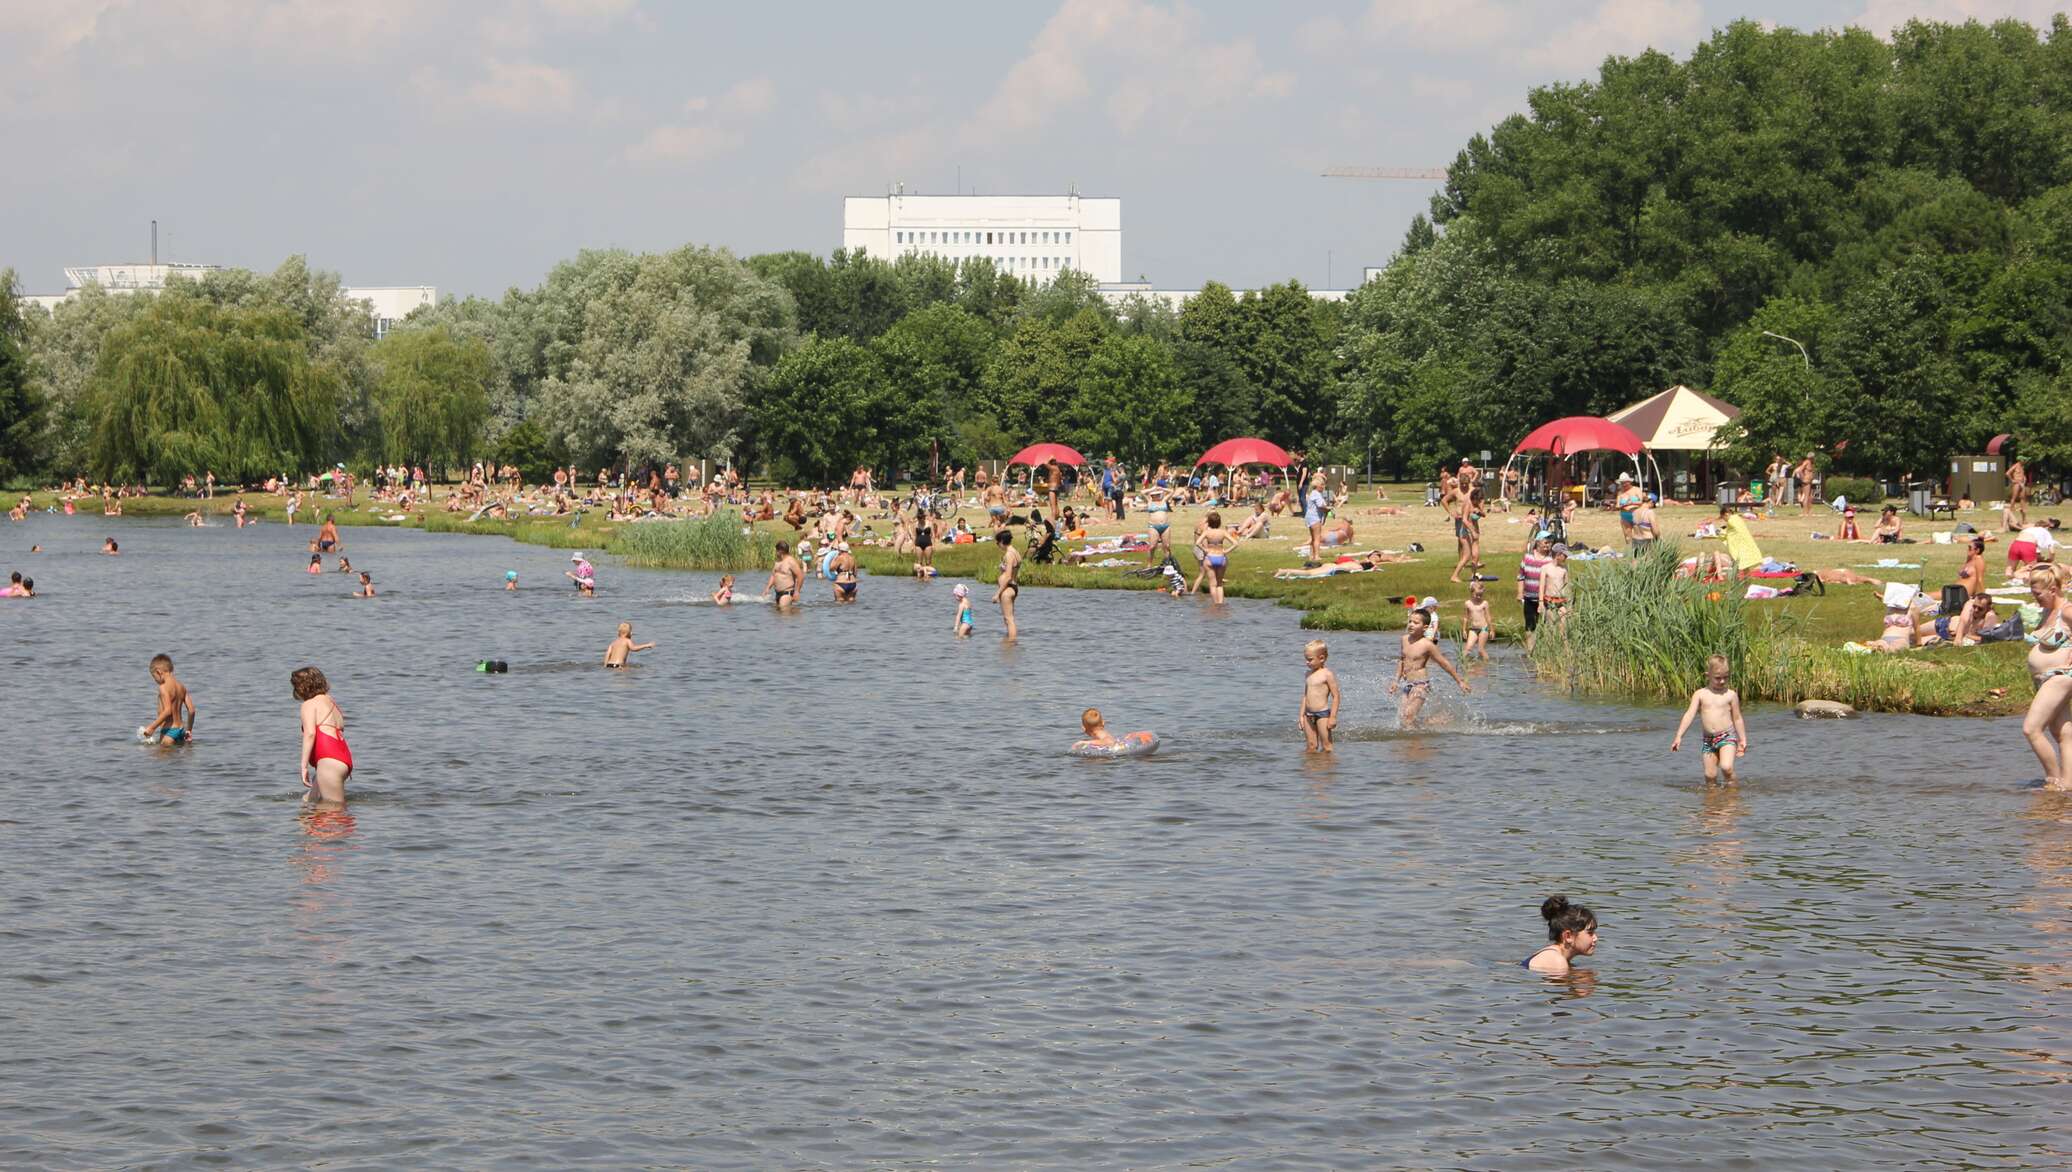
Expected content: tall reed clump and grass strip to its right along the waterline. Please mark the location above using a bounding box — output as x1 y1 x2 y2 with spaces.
1531 545 2028 714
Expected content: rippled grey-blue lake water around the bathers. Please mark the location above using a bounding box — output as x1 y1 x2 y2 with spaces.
0 518 2072 1168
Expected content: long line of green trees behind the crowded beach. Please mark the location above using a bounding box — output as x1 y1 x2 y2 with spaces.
0 17 2072 482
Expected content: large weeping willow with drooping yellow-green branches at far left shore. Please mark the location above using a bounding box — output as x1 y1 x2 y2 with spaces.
89 290 340 485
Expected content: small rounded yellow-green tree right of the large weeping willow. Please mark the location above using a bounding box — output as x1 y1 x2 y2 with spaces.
371 325 491 468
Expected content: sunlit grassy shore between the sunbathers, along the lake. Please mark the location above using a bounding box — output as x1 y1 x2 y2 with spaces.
35 487 2066 714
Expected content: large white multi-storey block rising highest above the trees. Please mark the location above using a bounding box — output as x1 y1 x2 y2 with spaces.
841 193 1123 284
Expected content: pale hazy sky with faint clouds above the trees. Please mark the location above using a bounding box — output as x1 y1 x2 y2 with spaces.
0 0 2068 296
